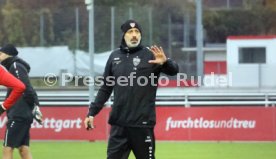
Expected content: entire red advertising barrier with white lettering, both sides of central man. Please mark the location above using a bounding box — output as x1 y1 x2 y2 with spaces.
0 107 276 141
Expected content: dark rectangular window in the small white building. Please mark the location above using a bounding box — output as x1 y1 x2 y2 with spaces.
239 47 266 64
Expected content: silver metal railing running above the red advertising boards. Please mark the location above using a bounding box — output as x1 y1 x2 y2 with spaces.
0 90 276 107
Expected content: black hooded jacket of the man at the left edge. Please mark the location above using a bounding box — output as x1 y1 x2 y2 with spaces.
2 56 39 123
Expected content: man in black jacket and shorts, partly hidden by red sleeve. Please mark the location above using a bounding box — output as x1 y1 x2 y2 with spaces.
0 44 42 159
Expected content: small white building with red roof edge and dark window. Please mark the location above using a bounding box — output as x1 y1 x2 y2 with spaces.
226 36 276 88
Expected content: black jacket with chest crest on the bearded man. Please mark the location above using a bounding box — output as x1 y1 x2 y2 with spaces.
88 46 178 127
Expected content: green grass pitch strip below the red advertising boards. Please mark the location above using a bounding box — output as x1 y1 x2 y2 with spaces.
0 141 276 159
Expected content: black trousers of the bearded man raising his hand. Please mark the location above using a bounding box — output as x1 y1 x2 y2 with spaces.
107 125 155 159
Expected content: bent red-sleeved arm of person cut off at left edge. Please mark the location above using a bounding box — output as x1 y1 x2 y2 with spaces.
0 65 25 115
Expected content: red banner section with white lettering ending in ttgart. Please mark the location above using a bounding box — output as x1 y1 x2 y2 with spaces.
0 106 109 140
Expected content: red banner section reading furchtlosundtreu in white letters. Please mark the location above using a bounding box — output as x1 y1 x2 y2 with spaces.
155 107 276 141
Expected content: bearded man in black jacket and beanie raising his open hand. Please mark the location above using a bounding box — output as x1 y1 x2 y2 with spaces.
84 20 178 159
